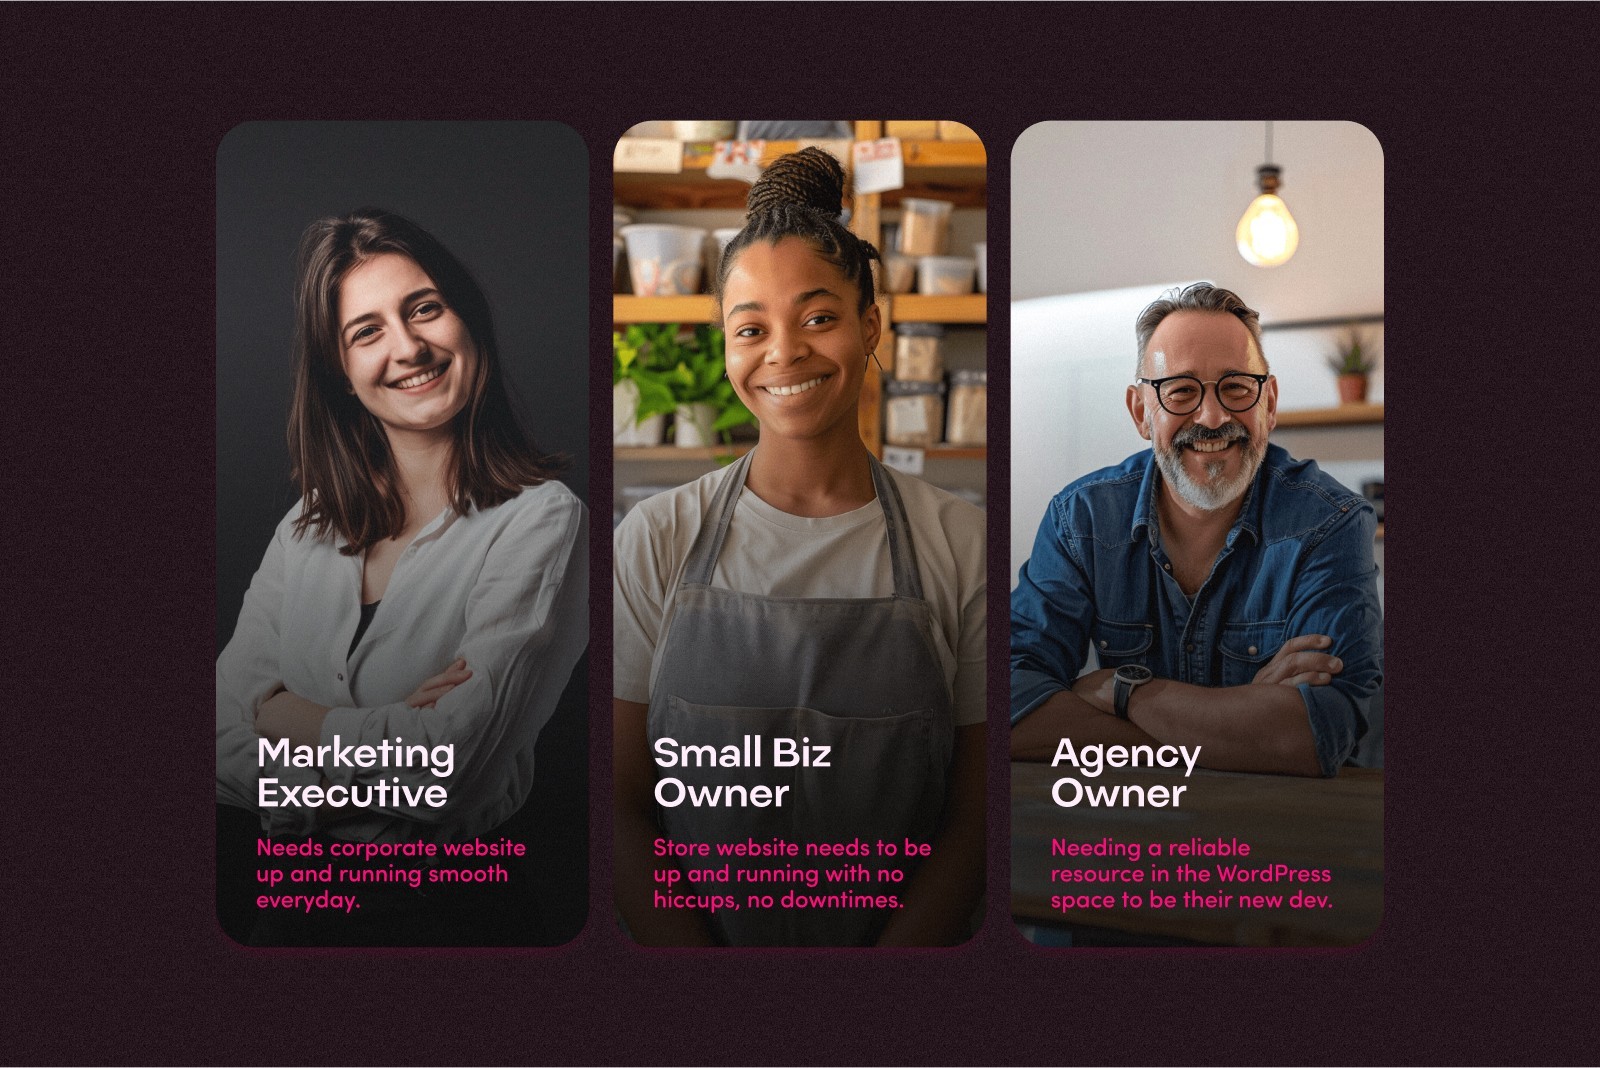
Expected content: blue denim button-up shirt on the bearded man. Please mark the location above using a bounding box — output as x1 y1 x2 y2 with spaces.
1011 444 1384 775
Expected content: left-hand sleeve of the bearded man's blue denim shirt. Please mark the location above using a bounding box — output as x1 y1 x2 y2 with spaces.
1011 497 1094 724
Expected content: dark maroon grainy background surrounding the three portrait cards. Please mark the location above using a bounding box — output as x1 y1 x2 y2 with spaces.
9 3 1600 1063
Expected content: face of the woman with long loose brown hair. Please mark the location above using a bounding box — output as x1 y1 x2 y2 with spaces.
336 253 478 440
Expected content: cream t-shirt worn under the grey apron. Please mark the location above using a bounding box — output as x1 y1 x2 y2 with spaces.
611 468 987 726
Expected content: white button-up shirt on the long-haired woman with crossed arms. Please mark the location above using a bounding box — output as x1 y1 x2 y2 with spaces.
216 481 589 841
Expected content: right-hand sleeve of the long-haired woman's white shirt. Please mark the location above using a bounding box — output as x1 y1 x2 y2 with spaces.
322 491 589 825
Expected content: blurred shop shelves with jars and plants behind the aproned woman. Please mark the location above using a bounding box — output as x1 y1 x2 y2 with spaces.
611 120 989 523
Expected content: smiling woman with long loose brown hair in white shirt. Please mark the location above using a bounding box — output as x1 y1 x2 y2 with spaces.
216 209 587 940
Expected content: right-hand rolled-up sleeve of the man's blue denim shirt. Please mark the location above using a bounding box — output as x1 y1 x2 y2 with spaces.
1288 504 1384 775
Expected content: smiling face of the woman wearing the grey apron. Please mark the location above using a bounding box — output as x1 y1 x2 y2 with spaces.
722 237 880 438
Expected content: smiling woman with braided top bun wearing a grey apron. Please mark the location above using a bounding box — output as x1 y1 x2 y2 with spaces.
613 149 986 945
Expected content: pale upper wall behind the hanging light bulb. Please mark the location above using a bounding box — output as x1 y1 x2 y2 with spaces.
1011 122 1384 321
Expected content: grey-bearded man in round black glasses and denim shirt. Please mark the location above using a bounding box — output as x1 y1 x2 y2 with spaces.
1011 283 1382 775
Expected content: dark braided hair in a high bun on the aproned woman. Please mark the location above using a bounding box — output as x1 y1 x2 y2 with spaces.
712 145 878 312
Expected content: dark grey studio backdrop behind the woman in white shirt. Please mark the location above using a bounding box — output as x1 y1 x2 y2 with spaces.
216 122 588 943
